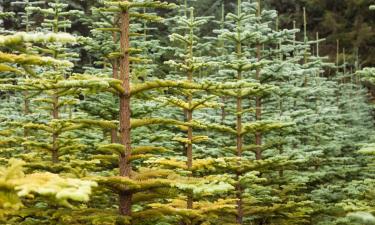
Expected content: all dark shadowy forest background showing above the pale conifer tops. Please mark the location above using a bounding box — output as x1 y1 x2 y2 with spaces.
0 0 375 67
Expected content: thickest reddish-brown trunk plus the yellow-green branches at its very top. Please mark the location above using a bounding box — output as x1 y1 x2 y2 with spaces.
97 1 176 216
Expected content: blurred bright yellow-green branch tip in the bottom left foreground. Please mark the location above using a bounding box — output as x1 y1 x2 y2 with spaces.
0 159 97 209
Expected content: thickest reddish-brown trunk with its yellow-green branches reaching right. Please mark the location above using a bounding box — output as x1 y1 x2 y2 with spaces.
88 1 272 223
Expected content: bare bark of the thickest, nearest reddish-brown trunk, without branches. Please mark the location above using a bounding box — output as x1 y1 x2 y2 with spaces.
119 7 132 216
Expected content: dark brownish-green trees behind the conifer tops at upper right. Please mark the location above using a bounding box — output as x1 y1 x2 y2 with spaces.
176 0 375 66
